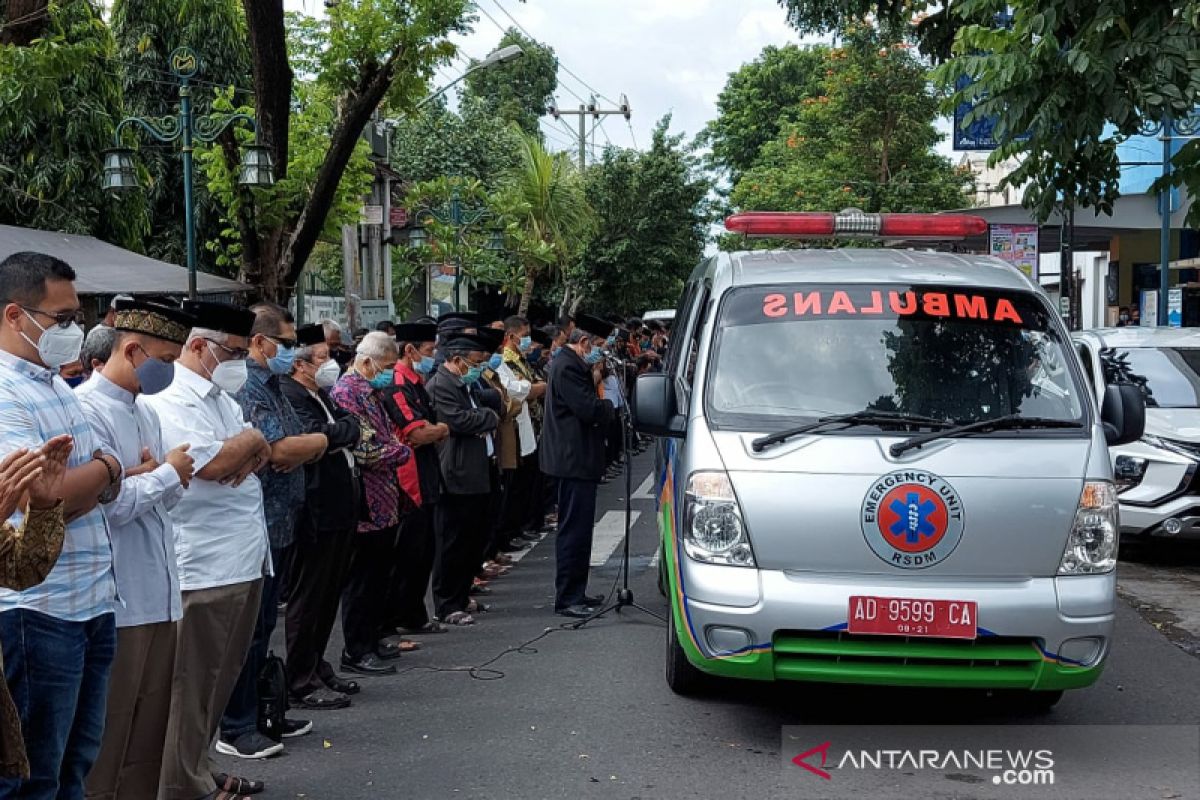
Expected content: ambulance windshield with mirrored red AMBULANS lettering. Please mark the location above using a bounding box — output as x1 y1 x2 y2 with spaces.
706 284 1084 435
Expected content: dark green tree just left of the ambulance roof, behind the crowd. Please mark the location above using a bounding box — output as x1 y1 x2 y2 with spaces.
582 116 709 315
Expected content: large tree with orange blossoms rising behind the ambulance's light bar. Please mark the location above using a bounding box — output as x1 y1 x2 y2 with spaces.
731 30 970 241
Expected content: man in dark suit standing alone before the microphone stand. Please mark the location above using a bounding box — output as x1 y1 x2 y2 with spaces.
539 317 616 618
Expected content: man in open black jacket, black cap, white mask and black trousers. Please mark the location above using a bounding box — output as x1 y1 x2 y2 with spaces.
281 325 362 710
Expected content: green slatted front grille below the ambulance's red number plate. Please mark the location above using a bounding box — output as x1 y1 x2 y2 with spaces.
774 631 1043 688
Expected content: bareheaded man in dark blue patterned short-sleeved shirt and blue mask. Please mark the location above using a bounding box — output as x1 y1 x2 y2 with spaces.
216 302 329 758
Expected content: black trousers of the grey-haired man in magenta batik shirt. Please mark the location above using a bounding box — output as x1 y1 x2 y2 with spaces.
342 527 396 658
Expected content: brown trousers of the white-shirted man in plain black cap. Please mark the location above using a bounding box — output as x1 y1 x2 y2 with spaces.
158 578 263 800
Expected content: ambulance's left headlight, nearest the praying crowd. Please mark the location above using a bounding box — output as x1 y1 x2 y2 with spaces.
683 473 756 566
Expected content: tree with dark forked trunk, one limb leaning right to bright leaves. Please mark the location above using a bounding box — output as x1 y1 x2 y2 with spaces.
196 0 469 300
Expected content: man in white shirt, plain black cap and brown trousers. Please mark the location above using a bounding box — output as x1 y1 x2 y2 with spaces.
145 301 273 800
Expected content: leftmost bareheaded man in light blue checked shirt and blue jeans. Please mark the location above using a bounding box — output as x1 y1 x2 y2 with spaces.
0 252 122 798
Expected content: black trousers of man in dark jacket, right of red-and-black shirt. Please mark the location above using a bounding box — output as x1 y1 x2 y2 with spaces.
433 494 491 619
